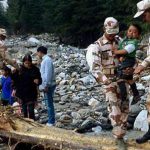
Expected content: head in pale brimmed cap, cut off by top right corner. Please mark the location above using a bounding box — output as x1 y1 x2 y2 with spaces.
134 0 150 23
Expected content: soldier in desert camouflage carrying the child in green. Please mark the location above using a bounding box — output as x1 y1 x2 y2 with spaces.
86 17 129 138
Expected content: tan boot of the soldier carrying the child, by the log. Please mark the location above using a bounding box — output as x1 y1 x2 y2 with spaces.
112 126 126 139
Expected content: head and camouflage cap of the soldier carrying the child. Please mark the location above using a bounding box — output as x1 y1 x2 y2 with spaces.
104 17 119 41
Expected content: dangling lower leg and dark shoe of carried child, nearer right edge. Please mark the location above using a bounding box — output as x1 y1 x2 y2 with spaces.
130 83 141 105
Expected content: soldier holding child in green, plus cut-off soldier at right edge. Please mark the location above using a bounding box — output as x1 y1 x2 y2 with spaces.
86 0 150 143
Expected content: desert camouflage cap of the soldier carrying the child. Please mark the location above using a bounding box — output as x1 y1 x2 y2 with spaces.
104 17 119 34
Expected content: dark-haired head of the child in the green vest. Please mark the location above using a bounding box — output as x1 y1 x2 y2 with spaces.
127 23 142 39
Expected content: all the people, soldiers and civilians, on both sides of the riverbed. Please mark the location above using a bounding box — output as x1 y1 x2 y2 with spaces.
0 0 150 143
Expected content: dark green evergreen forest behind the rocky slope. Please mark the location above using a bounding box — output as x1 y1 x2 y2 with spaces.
4 0 148 47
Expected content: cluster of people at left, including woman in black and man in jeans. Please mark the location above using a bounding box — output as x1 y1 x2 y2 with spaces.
0 28 56 126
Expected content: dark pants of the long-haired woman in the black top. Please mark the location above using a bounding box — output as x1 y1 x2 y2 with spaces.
22 102 35 120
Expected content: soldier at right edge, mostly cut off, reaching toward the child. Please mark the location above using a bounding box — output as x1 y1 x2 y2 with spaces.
134 0 150 144
